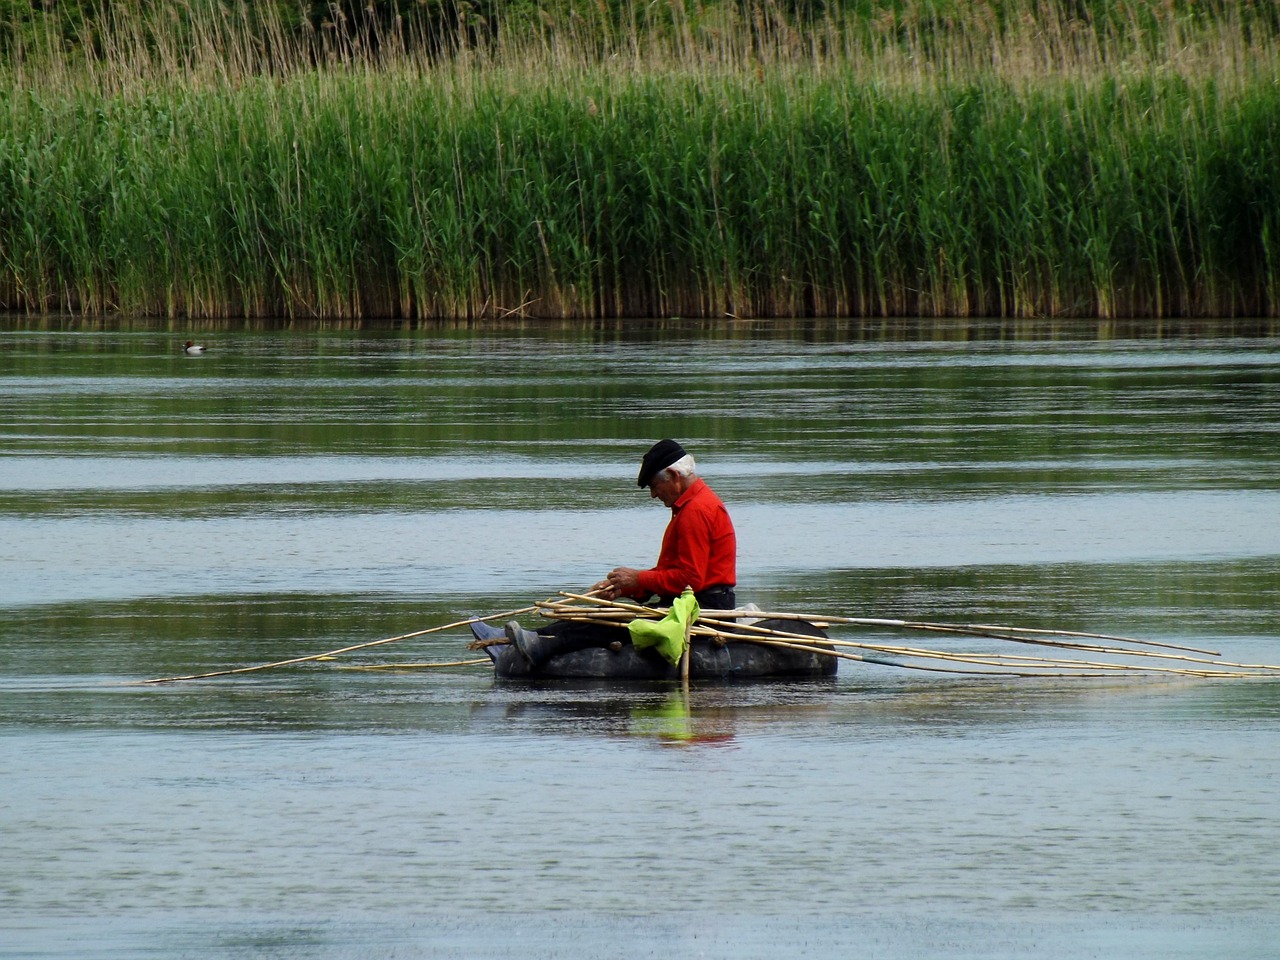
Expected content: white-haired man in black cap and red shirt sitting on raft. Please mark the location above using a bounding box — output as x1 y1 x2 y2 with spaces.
471 440 737 667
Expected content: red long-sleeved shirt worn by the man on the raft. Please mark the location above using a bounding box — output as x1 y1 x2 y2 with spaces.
637 479 737 598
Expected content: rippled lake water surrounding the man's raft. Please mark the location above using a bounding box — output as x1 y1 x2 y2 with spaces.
0 321 1280 960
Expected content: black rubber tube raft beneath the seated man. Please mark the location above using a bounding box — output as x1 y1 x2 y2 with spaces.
485 620 838 682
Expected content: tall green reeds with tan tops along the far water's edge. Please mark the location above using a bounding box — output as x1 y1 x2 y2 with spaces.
0 0 1280 317
